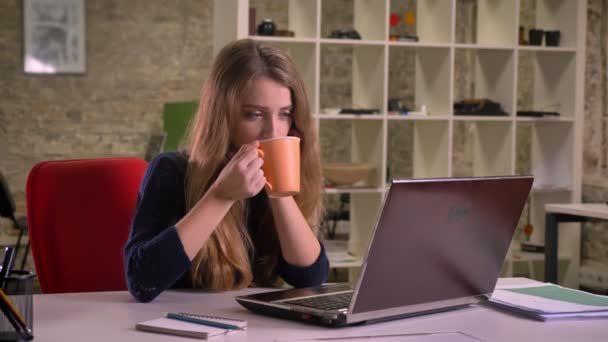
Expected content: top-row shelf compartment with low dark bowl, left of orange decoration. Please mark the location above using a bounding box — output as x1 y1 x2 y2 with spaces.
321 0 387 40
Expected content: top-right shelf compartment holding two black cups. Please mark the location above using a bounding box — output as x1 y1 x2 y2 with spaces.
520 0 580 48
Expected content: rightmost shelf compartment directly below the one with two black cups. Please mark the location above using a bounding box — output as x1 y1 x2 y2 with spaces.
517 50 576 118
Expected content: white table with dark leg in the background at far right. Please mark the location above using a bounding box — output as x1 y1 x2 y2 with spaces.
545 203 608 284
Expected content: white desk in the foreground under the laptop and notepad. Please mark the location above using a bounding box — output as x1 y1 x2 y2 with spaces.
34 278 608 342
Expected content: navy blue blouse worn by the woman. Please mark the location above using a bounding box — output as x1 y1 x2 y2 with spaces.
124 152 329 302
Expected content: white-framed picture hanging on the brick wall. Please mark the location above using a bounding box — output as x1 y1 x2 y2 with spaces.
23 0 86 74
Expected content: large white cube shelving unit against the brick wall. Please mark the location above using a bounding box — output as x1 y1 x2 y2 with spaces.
214 0 587 286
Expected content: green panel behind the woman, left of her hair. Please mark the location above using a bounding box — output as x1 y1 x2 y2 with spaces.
163 101 198 151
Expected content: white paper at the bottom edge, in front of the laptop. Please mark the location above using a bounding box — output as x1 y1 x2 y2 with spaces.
292 331 483 342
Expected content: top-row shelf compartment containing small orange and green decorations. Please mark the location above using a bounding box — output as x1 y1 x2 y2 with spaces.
389 0 453 43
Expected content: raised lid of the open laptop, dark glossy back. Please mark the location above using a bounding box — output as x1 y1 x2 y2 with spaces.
351 176 533 314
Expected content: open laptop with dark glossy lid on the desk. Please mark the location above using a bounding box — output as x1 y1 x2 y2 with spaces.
236 176 533 326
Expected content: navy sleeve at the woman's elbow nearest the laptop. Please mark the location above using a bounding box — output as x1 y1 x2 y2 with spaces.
277 241 329 287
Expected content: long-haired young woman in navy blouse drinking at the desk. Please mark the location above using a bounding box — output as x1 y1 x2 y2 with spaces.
124 39 329 302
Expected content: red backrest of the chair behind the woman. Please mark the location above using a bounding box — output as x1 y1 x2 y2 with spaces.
26 158 147 293
